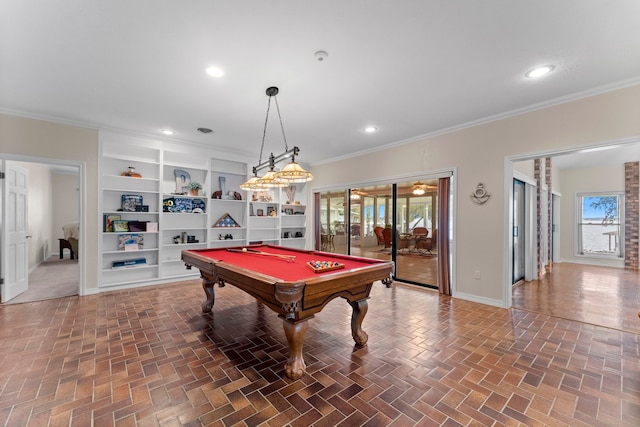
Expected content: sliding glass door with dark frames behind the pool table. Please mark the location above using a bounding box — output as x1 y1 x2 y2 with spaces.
316 179 438 287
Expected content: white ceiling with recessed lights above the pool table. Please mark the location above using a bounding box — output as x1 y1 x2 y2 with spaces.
0 0 640 169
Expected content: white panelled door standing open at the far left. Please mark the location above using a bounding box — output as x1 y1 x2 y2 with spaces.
1 161 31 302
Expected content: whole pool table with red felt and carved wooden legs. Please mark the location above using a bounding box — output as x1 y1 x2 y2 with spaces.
182 245 393 380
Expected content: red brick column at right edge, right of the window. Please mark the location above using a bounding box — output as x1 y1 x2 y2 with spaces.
624 162 640 270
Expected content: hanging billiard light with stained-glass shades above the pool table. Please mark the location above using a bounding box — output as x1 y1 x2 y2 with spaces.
240 86 313 191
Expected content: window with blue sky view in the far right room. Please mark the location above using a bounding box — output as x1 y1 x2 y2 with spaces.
576 192 624 257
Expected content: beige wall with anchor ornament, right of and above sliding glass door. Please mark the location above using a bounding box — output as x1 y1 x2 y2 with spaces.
310 85 640 305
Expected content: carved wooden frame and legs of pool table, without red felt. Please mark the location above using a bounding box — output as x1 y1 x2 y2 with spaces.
182 245 393 380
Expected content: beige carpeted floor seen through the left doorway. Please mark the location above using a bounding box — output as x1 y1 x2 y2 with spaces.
7 255 80 304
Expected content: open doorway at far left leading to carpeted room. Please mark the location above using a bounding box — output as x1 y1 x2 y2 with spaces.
0 155 84 304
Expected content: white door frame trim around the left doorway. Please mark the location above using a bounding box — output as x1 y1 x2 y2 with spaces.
0 153 87 296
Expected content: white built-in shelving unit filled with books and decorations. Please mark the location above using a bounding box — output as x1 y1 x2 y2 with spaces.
99 133 308 287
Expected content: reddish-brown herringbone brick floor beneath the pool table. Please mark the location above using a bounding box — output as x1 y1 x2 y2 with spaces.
0 281 640 427
